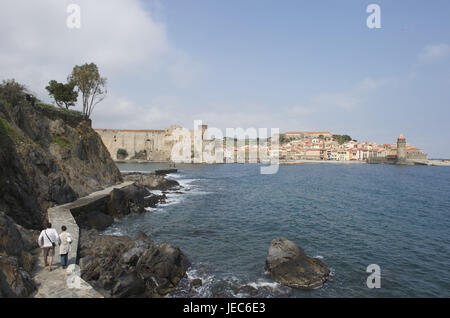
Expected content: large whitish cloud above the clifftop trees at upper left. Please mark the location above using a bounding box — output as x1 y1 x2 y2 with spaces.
0 0 197 98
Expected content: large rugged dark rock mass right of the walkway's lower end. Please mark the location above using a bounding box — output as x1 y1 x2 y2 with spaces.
79 230 190 297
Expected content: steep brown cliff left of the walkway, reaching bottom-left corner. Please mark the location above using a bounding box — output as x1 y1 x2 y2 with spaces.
0 99 122 297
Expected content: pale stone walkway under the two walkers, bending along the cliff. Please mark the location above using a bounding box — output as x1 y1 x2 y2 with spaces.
33 181 133 298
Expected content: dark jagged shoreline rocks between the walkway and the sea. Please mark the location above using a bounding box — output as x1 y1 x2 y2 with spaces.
72 170 190 298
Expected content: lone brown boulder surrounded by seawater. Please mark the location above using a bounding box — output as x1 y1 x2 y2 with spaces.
266 238 330 289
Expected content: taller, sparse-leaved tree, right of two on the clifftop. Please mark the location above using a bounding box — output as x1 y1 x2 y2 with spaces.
67 63 107 118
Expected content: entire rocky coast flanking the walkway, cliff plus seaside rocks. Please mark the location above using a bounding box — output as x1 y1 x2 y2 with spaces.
0 98 193 298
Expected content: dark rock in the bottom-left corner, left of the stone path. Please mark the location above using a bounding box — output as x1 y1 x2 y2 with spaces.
0 256 36 298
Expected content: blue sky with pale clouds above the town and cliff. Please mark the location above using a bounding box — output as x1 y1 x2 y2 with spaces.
0 0 450 158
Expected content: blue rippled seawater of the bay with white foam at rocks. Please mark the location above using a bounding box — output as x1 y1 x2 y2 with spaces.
105 163 450 297
